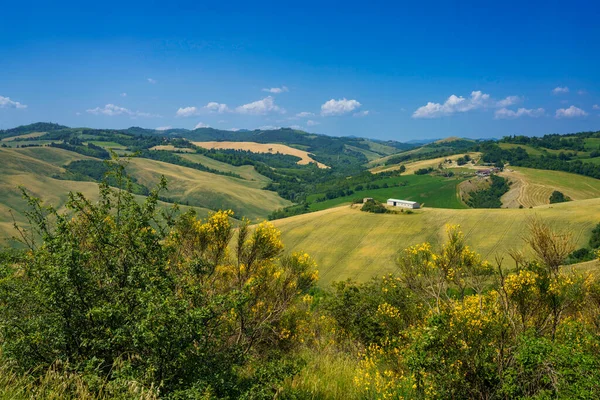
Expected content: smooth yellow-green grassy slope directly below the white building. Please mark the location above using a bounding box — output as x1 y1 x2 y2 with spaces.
275 199 600 284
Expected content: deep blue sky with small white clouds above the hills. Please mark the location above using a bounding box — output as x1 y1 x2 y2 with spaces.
0 1 600 140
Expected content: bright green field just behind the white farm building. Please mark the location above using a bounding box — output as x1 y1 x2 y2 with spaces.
309 175 467 211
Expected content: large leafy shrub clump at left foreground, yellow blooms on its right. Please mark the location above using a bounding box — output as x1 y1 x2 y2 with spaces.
0 159 317 397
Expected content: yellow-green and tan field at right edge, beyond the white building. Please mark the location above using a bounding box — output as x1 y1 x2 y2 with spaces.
500 167 600 208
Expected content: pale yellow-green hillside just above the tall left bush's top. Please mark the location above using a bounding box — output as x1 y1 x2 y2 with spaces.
127 158 292 219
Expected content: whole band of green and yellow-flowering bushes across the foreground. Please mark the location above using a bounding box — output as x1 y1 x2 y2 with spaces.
0 164 600 399
